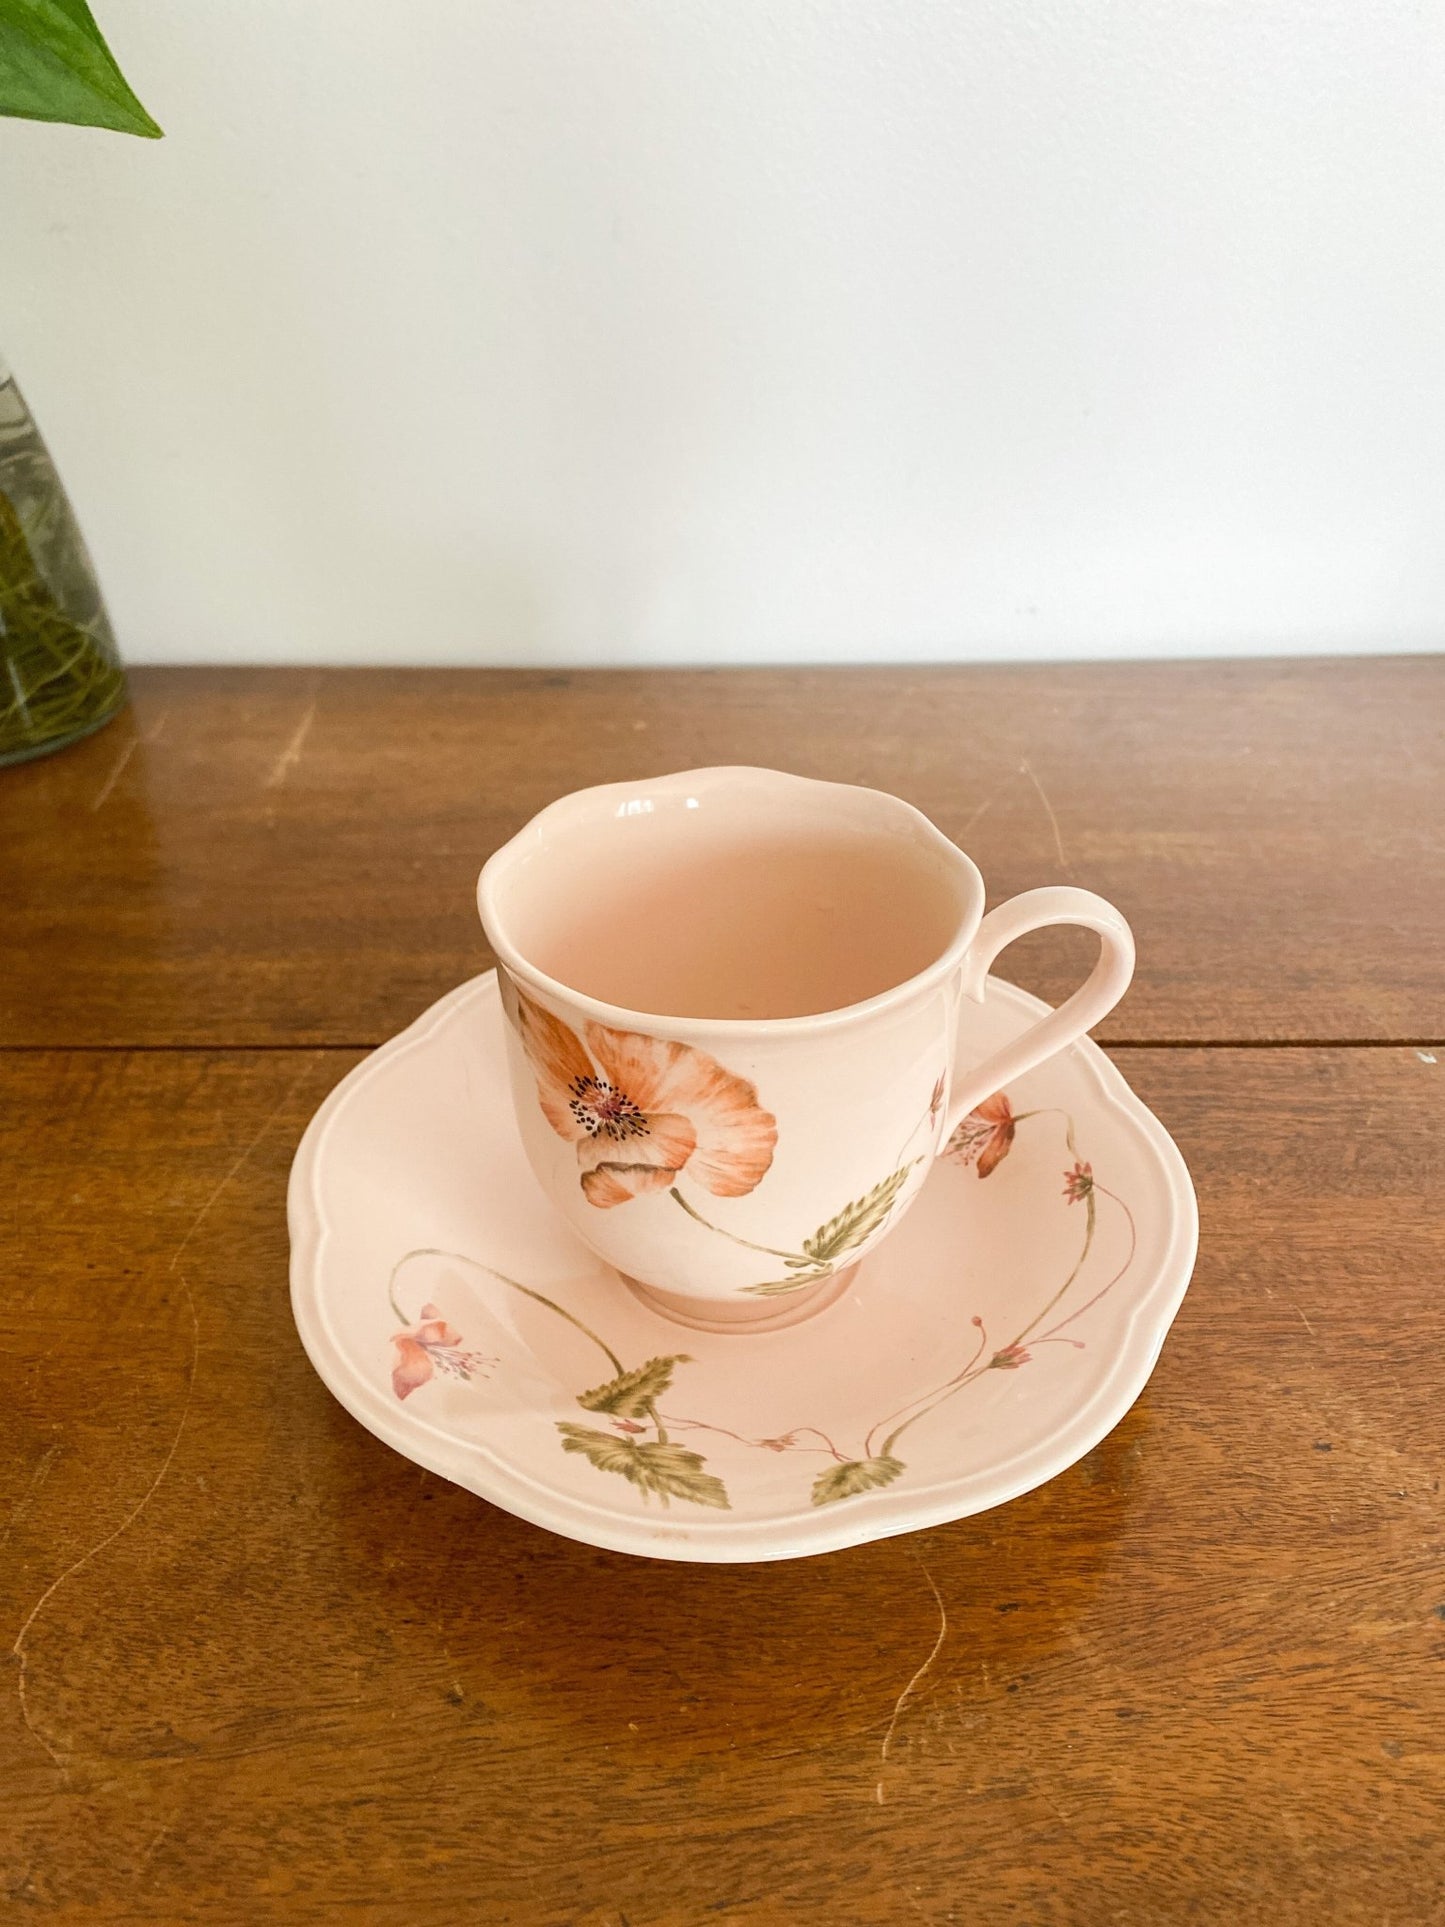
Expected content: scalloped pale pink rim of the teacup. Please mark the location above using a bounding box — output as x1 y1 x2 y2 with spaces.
476 763 986 1039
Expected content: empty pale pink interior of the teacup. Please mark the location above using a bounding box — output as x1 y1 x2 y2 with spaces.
497 779 969 1019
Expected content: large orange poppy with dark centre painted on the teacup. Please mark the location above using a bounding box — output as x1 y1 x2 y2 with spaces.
514 992 778 1210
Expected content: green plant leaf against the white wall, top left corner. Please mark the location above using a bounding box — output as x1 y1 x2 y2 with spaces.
0 0 162 141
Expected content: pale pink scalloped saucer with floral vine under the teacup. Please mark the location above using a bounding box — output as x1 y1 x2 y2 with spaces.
289 971 1198 1563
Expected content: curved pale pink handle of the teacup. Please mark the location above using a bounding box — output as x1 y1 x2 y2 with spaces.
948 884 1135 1137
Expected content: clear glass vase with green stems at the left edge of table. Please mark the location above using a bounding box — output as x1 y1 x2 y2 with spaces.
0 360 125 765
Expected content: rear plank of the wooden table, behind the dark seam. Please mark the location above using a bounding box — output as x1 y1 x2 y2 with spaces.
0 657 1445 1044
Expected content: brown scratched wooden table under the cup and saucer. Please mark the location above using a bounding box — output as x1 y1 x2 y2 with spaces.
0 659 1445 1927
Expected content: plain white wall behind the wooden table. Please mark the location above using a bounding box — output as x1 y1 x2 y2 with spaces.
0 0 1445 663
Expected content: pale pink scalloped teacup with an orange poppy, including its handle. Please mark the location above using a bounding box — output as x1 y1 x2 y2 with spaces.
478 769 1135 1330
